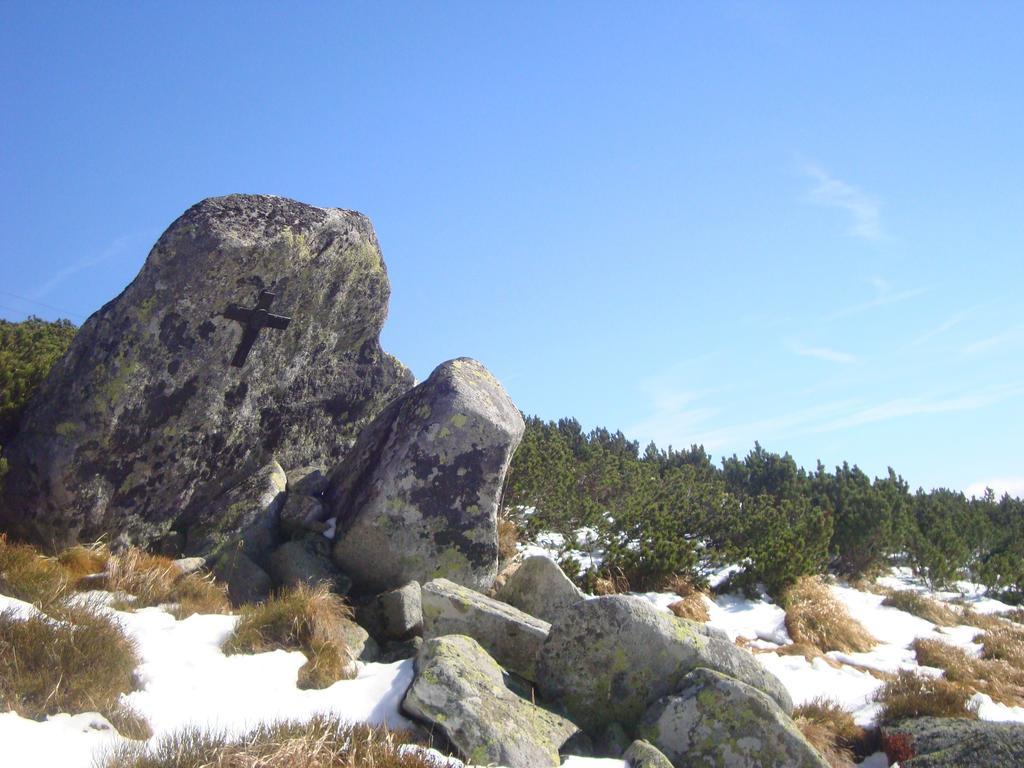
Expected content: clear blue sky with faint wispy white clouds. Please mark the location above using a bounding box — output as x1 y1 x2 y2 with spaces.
0 2 1024 494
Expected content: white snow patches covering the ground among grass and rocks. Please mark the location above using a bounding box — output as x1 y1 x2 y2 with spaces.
0 565 1024 768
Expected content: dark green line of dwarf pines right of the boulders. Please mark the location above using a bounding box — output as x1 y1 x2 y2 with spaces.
504 417 1024 601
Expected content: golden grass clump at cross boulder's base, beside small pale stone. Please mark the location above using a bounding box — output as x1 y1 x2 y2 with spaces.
103 549 231 618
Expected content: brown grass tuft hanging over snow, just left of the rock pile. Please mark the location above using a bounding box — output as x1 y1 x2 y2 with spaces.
224 585 354 688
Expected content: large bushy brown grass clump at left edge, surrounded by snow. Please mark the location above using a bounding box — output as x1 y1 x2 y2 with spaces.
0 605 148 737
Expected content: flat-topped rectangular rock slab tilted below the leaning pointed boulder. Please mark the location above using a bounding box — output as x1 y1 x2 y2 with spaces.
423 579 551 682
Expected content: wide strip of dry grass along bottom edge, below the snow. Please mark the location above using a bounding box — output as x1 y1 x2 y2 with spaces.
98 715 444 768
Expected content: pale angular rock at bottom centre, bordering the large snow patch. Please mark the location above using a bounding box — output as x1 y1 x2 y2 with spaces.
402 635 579 768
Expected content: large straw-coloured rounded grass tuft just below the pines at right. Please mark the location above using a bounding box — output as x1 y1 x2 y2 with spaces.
781 577 878 652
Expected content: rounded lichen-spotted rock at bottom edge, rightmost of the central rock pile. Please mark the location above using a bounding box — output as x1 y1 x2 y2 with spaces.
640 669 828 768
